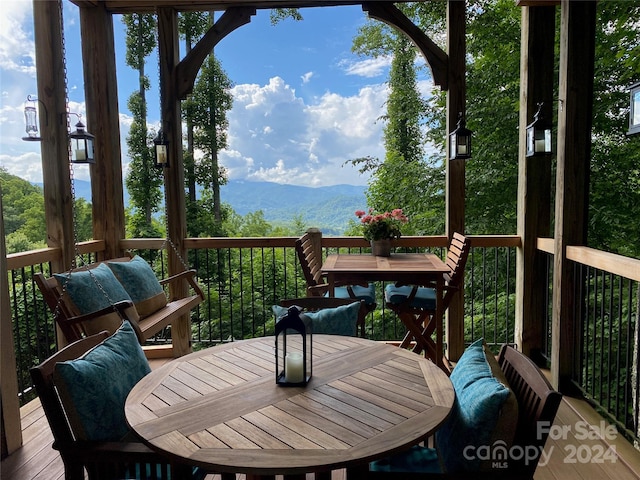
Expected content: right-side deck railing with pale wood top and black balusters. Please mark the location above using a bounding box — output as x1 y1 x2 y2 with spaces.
538 238 640 441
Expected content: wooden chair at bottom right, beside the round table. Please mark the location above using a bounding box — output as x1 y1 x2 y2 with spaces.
358 345 562 480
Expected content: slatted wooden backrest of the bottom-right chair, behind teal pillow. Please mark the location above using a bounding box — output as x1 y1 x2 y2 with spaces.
498 345 562 478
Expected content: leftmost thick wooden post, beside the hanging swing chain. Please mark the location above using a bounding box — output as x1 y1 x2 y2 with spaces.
33 0 75 272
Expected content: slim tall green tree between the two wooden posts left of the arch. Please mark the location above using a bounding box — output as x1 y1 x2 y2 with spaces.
122 13 162 237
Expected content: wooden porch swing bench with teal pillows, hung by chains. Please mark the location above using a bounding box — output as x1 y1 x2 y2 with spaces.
34 253 204 344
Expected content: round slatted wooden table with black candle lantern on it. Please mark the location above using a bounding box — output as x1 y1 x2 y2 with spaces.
125 335 454 478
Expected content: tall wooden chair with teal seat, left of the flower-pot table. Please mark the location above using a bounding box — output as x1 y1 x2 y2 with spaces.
296 233 376 312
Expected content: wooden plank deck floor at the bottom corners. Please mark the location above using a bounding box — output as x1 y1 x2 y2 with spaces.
0 370 640 480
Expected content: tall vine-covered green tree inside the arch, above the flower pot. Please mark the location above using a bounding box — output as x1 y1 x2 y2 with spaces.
352 6 444 234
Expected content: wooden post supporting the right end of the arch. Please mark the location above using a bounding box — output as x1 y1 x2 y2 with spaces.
445 0 467 361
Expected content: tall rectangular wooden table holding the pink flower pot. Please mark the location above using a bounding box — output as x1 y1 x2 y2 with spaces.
322 253 450 368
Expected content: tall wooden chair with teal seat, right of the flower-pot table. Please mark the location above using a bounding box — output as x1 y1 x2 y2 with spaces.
385 232 471 363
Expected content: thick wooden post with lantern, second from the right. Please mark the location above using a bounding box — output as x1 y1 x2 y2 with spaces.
515 6 555 361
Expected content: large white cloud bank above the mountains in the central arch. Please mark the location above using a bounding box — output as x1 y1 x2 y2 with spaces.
220 77 387 186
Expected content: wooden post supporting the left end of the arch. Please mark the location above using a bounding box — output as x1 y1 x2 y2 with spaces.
158 7 191 357
